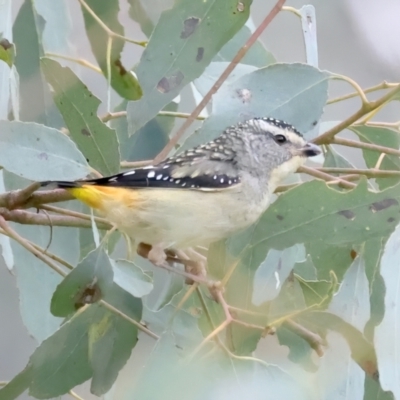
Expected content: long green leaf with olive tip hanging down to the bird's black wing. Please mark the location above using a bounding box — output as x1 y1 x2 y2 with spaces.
42 58 120 175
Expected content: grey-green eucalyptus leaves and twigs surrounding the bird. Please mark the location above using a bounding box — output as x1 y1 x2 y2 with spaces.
0 0 400 400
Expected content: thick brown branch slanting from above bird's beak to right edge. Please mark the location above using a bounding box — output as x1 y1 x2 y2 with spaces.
312 84 400 144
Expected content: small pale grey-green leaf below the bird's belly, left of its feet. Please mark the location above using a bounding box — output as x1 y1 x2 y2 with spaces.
112 260 153 297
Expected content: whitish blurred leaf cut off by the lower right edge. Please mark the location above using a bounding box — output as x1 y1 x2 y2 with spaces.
374 226 400 398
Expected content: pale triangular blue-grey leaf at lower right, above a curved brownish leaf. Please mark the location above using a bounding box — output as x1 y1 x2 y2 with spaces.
328 252 370 332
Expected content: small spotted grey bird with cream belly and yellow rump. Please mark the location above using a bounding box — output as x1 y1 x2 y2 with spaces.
43 118 321 265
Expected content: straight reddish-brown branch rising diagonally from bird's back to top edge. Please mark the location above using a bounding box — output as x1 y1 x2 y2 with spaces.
154 0 285 164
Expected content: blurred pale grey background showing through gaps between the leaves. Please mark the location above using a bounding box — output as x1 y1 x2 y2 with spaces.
0 0 400 399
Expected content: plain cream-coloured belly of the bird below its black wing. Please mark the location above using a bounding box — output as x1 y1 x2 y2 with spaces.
98 189 266 249
